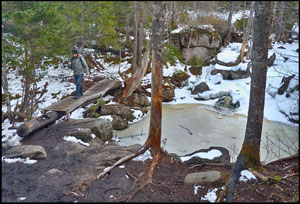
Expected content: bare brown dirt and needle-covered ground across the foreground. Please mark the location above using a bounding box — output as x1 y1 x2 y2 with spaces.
2 119 299 202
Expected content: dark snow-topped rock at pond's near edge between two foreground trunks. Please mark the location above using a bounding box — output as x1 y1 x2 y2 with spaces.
184 146 230 165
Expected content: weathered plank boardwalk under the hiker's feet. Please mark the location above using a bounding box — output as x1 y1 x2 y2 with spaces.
43 79 121 118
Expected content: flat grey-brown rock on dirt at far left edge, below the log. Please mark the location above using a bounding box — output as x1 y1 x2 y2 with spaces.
5 145 47 159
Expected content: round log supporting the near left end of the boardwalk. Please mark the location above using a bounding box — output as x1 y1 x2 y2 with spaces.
17 112 65 137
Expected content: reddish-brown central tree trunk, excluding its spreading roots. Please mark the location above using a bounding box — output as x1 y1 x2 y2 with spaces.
146 1 166 155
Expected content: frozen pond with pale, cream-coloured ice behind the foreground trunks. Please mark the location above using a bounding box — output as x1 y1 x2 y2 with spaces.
114 104 299 162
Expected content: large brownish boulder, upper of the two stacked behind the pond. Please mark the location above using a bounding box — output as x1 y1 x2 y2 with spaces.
179 27 222 48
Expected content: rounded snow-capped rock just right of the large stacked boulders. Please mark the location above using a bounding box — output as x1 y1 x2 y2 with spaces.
216 50 241 67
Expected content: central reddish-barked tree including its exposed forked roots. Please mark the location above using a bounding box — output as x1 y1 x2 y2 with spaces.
97 1 167 198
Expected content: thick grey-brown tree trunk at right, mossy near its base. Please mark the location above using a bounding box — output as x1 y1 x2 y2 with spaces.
225 1 271 202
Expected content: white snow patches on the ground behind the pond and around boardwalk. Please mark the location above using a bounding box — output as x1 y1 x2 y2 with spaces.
2 41 299 149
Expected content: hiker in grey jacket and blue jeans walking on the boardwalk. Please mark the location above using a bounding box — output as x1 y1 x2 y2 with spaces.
68 50 89 99
